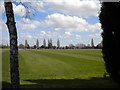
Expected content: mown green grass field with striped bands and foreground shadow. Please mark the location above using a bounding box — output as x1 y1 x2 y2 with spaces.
2 49 119 88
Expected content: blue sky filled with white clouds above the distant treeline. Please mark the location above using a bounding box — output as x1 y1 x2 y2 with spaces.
0 0 102 46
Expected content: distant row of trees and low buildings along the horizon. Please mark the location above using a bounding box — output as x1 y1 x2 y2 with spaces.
0 39 103 49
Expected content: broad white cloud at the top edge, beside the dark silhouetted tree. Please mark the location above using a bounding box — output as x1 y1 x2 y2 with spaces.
45 0 100 17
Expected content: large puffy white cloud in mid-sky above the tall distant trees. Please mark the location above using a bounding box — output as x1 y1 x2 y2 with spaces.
41 13 101 32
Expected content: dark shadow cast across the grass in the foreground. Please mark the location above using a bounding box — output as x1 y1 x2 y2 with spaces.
2 78 120 88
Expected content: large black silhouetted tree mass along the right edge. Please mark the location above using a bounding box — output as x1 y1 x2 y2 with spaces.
99 2 120 81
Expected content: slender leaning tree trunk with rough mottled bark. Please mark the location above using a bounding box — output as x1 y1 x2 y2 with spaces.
4 2 20 88
